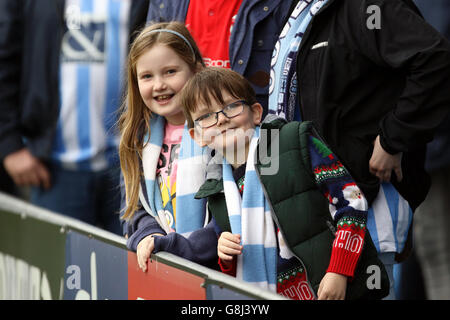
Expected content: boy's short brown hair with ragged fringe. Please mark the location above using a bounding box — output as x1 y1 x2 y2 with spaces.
180 67 258 128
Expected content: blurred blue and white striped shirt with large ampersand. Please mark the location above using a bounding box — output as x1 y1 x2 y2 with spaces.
52 0 131 171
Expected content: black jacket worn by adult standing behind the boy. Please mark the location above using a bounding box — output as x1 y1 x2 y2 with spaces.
297 0 450 210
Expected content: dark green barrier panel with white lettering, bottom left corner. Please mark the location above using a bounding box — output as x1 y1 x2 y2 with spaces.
0 211 65 300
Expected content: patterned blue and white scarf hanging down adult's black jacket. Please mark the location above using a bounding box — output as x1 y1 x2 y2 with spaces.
269 0 328 121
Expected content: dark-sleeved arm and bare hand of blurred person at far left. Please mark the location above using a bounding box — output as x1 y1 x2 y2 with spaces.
0 0 50 189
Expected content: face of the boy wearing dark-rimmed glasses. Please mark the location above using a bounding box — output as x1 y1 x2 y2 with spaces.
189 92 263 155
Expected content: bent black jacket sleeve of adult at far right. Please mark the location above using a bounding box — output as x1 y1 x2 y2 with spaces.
358 0 450 155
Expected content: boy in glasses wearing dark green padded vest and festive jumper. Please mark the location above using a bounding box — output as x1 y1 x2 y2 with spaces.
181 68 388 299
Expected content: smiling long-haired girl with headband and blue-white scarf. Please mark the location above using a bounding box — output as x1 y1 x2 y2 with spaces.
119 22 217 271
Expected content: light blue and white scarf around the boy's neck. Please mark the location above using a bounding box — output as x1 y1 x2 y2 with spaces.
222 127 277 292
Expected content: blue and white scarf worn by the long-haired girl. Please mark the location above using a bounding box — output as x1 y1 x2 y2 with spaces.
139 115 208 237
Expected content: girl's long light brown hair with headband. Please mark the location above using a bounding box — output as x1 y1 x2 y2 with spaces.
118 22 204 219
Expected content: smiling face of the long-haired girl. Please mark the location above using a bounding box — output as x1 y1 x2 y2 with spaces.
136 44 194 125
